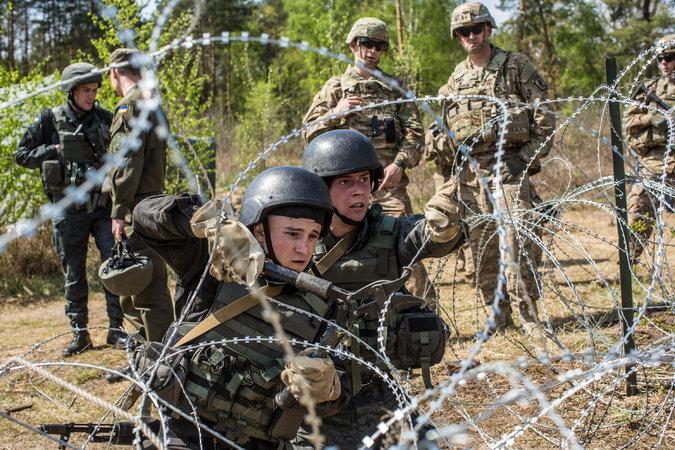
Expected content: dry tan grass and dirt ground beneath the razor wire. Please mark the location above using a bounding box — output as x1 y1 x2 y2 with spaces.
0 209 675 449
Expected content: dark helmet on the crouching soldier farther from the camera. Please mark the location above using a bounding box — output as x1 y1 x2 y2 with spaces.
302 130 384 192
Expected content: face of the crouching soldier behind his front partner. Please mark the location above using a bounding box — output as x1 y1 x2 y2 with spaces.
328 170 371 222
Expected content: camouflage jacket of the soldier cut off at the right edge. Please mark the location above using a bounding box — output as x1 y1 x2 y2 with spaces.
626 78 675 156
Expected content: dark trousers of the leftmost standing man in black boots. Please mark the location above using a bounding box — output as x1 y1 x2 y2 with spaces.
52 200 122 328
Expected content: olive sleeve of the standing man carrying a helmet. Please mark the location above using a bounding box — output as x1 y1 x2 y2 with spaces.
109 104 147 220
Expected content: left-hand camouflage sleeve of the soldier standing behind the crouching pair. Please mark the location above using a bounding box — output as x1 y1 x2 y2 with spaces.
302 77 346 144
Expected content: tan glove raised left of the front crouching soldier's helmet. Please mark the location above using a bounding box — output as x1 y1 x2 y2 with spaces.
190 200 265 286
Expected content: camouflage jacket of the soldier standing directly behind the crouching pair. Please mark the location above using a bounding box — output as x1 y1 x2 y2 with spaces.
302 66 424 168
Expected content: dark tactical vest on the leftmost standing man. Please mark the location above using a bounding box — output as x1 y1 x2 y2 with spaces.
42 107 110 194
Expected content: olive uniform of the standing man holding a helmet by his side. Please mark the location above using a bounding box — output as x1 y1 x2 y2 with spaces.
106 51 174 341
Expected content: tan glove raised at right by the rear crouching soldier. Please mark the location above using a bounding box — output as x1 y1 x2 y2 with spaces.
424 180 462 243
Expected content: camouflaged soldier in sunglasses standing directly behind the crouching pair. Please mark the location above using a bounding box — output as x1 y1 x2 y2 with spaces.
303 17 435 301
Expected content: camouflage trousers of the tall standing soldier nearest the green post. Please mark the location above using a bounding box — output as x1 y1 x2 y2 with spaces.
459 168 539 322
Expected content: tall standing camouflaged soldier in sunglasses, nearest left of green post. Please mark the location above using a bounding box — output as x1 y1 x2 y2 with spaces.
434 2 555 332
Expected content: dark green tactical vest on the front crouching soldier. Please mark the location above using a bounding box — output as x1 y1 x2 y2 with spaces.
180 283 327 446
